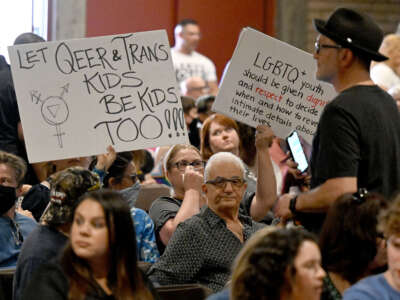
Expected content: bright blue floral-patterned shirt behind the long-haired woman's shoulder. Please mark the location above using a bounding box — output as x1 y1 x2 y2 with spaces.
131 207 160 263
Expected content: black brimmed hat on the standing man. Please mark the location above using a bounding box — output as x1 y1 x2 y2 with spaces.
313 8 388 61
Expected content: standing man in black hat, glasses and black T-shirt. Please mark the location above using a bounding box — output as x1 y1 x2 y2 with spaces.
275 8 400 232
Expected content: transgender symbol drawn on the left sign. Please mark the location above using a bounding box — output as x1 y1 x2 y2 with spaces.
31 84 69 148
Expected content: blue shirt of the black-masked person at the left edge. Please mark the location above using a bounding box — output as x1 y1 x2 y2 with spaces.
0 213 37 268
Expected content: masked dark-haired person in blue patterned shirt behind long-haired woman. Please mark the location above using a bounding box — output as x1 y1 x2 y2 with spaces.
104 151 160 263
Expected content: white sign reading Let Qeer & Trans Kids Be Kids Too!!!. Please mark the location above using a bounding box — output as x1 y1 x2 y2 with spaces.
9 30 188 162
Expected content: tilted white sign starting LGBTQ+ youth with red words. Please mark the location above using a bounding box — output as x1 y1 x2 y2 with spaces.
213 28 336 143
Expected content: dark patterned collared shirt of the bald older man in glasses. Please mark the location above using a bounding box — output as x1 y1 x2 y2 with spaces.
149 207 265 291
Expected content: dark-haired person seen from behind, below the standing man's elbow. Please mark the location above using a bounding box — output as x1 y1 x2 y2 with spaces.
319 189 386 300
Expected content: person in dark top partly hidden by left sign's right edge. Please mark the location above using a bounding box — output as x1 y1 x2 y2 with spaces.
181 96 201 148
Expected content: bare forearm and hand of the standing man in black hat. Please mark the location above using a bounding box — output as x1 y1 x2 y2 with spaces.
275 177 357 220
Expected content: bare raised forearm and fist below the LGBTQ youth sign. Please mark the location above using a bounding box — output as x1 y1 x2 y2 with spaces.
250 125 277 221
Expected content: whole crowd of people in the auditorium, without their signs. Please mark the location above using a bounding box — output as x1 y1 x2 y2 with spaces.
0 8 400 300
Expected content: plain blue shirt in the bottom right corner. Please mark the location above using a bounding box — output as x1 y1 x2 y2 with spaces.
343 274 400 300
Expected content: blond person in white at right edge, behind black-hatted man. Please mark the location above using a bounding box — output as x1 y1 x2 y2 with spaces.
370 34 400 90
